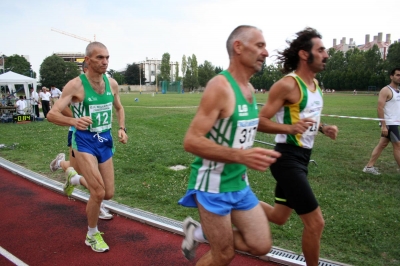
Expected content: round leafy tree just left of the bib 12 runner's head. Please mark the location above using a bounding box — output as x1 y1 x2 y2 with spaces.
39 55 80 88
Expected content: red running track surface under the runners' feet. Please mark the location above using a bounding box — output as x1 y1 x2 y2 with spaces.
0 168 276 266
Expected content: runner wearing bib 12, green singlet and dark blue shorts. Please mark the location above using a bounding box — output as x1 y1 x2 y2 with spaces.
48 42 128 252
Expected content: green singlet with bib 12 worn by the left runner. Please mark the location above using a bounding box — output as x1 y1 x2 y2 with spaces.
71 74 114 133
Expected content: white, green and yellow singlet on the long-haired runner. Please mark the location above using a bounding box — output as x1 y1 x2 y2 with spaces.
275 73 323 149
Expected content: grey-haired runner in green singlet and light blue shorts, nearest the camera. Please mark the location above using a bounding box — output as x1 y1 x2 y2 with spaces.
179 26 279 265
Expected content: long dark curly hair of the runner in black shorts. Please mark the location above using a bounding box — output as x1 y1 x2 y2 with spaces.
277 27 322 74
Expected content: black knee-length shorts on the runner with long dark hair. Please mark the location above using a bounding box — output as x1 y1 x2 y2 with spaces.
270 143 318 215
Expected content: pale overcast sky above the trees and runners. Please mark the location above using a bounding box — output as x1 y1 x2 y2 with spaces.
0 0 400 78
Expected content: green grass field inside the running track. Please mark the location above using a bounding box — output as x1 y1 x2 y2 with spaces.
0 93 400 266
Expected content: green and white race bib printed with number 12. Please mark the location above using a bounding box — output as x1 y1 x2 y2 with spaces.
89 103 112 132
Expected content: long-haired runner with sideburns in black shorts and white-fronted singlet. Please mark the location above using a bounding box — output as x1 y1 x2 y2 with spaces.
258 28 338 266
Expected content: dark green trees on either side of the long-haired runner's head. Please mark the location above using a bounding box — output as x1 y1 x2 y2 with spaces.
250 42 400 91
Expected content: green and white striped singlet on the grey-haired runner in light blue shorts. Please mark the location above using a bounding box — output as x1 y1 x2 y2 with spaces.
188 70 258 193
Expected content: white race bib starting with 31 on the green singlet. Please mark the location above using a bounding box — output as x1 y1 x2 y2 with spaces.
232 118 258 150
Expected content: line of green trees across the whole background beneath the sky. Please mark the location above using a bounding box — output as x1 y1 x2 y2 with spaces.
2 42 400 94
